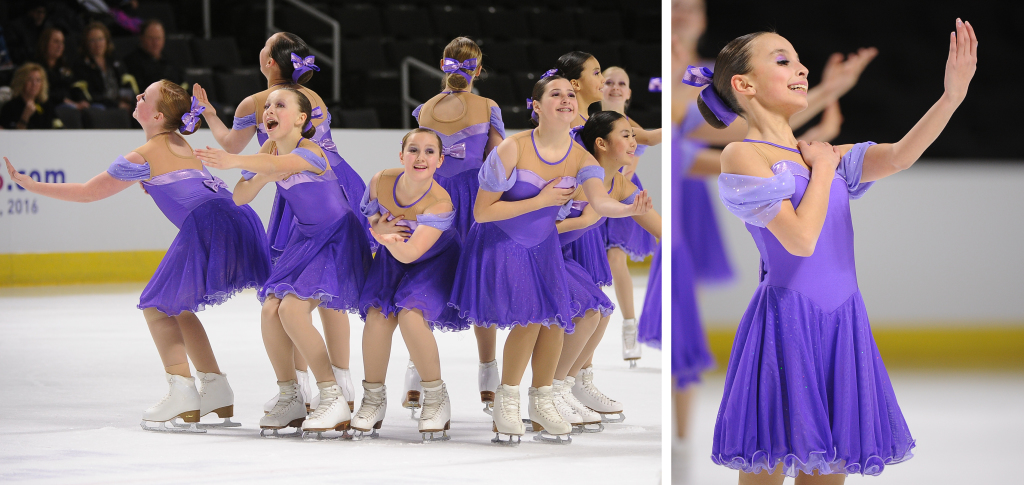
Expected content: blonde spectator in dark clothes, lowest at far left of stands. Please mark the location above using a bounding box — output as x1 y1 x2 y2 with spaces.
0 62 60 130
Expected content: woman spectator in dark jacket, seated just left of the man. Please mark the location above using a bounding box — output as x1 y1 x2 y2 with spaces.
73 21 138 109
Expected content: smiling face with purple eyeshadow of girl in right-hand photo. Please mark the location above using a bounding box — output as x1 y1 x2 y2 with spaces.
733 34 807 116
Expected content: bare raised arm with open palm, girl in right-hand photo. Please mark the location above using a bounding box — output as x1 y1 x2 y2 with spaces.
856 18 978 182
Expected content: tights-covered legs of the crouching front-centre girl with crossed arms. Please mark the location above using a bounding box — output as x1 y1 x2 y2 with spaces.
362 308 441 383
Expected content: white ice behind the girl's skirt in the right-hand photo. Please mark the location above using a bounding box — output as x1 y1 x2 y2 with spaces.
667 369 1024 485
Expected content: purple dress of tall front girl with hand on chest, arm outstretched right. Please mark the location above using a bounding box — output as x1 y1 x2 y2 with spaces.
450 130 604 333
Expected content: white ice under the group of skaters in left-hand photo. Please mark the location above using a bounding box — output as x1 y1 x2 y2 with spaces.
0 278 662 485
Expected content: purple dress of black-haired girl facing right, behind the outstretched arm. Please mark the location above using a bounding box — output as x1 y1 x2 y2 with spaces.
558 173 640 318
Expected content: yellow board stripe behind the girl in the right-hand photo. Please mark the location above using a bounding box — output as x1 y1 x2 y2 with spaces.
708 322 1024 371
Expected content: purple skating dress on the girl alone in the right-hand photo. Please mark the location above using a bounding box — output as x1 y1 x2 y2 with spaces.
712 142 914 477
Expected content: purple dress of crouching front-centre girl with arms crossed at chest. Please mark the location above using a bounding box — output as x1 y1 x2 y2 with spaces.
359 169 470 330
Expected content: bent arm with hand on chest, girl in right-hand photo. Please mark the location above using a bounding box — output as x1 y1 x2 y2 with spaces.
719 141 840 257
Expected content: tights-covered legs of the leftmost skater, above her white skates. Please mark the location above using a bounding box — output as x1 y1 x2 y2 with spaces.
142 308 220 378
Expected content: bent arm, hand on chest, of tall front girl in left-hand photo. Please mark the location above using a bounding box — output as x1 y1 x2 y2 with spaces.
473 140 577 222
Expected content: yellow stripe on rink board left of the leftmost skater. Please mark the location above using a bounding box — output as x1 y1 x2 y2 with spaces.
0 251 167 286
